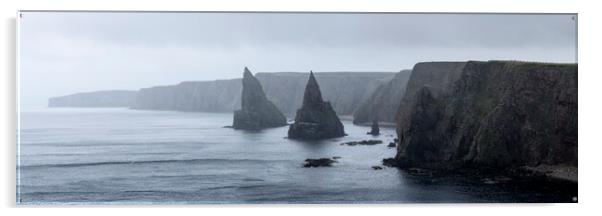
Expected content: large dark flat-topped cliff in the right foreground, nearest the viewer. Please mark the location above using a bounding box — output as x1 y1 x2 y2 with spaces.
395 61 577 168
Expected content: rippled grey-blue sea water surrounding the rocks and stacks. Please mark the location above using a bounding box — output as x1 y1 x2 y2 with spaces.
17 108 571 204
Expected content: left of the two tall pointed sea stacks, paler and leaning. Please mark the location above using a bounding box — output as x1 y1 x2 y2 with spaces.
232 67 286 130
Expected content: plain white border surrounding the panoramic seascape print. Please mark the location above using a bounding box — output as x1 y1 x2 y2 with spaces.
0 0 602 216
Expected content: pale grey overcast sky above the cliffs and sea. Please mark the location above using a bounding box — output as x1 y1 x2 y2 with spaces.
18 12 577 106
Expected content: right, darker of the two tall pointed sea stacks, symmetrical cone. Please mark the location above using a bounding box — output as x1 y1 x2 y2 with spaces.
288 71 345 139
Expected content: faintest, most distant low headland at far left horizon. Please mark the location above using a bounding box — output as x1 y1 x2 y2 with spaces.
48 90 137 107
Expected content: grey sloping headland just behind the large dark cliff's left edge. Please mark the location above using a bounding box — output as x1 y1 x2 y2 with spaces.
353 70 412 124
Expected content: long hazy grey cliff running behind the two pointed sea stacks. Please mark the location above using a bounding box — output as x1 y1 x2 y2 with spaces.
132 72 394 116
